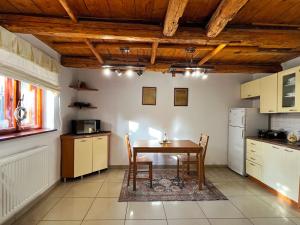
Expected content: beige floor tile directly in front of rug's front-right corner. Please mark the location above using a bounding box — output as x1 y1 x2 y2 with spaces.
198 201 245 218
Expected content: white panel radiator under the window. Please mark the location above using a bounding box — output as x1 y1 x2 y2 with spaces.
0 146 49 224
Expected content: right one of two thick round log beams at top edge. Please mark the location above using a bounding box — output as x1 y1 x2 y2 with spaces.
207 0 249 38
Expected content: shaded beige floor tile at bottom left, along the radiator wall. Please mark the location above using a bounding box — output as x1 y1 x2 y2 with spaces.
15 197 60 225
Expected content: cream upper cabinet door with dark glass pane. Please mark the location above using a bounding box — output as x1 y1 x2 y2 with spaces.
278 67 300 112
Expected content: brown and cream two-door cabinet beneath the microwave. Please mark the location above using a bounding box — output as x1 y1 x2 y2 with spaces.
61 132 110 178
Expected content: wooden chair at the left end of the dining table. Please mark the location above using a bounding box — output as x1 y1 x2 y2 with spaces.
125 134 152 188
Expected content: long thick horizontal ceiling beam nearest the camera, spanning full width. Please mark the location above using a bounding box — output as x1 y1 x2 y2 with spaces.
0 14 300 48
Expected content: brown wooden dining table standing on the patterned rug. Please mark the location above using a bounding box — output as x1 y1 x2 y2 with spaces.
132 140 204 191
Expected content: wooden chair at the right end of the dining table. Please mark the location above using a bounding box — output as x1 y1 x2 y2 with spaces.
177 134 209 183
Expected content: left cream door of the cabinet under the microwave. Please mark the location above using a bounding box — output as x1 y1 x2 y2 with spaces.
74 138 93 177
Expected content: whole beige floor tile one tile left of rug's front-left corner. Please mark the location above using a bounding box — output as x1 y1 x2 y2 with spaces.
64 182 102 197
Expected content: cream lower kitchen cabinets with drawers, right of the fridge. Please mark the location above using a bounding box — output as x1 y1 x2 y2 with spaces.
246 139 300 202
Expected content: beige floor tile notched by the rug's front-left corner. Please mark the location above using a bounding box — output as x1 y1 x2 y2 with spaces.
85 198 127 220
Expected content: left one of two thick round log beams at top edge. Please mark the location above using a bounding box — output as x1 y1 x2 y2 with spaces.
163 0 189 37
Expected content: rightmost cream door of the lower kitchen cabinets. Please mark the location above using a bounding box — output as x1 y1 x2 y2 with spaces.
280 148 300 201
